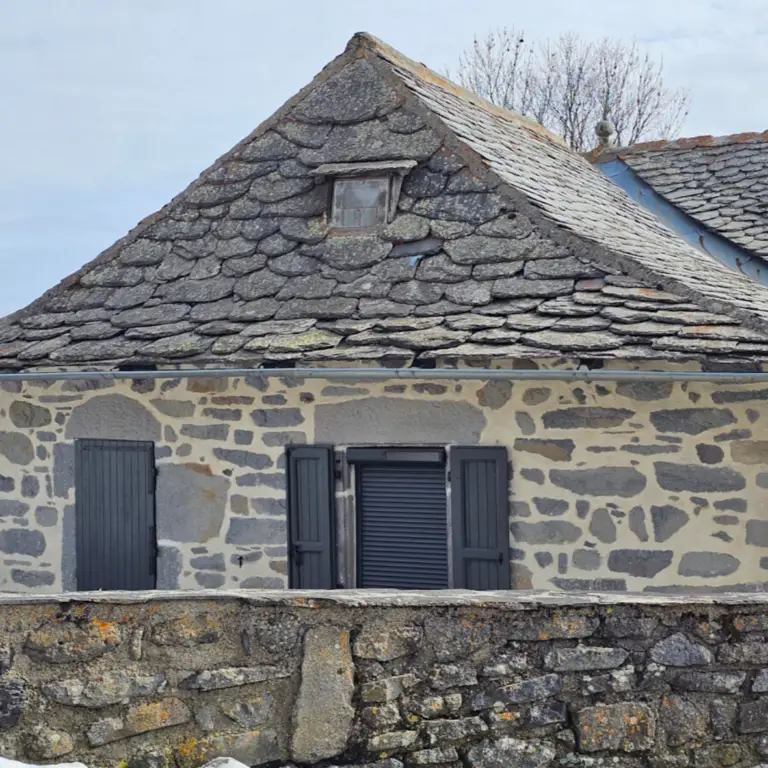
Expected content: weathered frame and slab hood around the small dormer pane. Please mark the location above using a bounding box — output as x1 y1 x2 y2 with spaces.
310 160 417 234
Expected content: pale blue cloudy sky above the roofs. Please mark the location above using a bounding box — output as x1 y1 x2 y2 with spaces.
0 0 768 317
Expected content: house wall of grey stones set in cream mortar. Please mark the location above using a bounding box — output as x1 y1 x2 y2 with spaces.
0 361 768 592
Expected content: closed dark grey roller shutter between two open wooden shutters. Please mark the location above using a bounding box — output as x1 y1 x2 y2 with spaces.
358 463 448 589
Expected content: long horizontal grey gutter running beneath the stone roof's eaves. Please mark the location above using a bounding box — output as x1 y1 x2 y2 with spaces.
0 368 768 384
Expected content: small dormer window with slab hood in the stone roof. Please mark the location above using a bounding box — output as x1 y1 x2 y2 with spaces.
311 160 416 230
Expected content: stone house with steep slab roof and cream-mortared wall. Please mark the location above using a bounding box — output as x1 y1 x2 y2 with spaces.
0 34 768 592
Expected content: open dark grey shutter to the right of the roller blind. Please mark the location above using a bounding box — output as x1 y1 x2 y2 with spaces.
450 446 510 589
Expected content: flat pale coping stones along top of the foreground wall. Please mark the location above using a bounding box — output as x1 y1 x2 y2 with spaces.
0 589 768 611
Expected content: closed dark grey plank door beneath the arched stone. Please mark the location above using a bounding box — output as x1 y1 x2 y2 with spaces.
75 440 157 590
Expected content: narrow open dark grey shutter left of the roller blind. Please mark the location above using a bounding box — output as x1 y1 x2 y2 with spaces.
287 445 337 589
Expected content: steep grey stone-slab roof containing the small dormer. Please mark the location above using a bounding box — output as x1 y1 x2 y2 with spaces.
0 35 768 369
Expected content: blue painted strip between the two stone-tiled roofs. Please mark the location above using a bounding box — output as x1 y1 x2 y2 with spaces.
596 159 768 286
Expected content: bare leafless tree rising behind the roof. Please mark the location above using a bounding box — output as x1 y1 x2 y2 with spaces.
458 28 690 151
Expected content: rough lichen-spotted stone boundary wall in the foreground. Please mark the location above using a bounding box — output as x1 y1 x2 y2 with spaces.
0 591 768 768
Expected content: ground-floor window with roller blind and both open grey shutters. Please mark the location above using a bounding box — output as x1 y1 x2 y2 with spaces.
287 446 510 590
